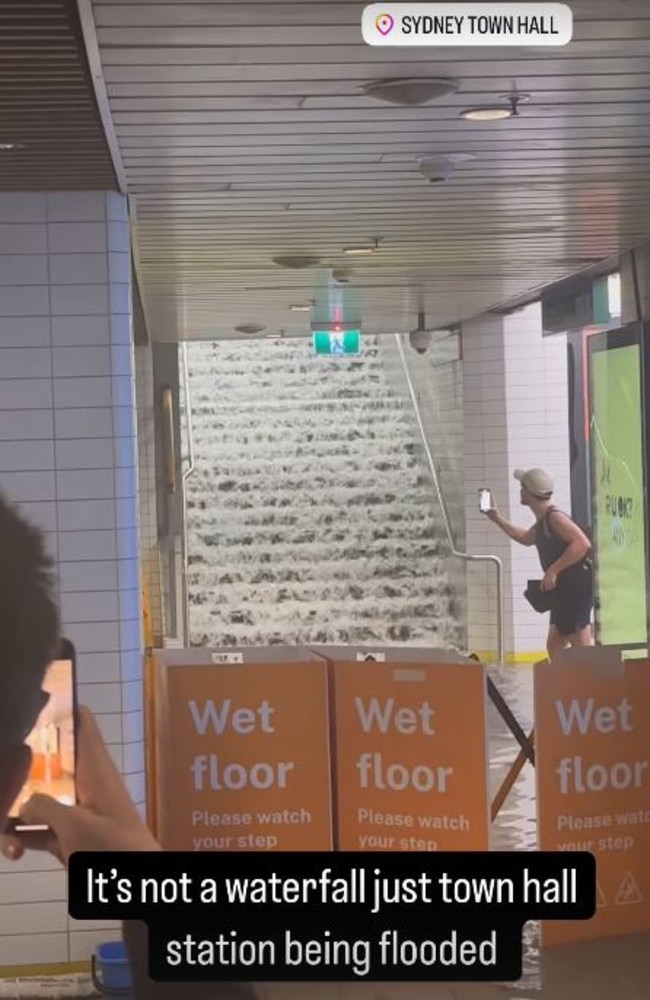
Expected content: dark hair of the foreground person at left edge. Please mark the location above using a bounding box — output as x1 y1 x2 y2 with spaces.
0 493 59 737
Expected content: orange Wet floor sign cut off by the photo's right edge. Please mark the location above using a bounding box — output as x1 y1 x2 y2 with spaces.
535 654 650 945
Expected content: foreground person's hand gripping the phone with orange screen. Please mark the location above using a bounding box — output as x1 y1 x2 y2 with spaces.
2 708 161 865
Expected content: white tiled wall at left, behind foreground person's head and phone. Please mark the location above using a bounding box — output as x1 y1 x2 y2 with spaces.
0 192 144 965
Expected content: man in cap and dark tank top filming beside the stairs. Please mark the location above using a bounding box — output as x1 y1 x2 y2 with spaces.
487 469 593 659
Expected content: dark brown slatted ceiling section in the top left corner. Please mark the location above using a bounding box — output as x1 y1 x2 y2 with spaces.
0 0 116 191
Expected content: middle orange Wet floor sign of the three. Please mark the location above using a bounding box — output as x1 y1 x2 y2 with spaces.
333 662 489 851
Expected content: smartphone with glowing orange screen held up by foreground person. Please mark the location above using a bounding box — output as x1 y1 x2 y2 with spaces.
7 639 77 835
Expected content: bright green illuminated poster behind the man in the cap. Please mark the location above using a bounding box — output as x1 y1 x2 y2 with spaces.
591 344 647 645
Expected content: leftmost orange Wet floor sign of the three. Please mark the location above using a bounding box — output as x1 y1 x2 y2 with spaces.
156 662 332 851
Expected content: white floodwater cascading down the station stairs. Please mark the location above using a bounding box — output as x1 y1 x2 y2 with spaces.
188 338 459 648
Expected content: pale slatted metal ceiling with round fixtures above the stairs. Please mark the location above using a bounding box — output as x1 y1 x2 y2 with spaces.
87 0 650 340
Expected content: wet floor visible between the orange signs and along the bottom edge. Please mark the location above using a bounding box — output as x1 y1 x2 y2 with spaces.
5 667 650 1000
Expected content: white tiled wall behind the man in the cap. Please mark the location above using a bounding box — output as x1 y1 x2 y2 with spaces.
463 304 570 657
